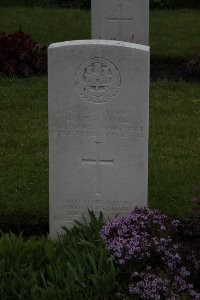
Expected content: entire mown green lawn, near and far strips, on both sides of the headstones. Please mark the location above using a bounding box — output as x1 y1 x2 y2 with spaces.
0 7 200 224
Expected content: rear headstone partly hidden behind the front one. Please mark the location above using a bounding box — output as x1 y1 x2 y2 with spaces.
91 0 149 45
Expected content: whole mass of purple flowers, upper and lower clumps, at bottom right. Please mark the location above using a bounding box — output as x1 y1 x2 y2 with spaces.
100 208 200 300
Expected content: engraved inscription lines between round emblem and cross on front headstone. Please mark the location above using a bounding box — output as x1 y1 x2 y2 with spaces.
49 107 145 138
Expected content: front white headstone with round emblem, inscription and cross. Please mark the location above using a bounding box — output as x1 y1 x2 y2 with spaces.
48 40 149 239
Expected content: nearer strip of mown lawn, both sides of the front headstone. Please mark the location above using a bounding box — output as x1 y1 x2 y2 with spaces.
0 76 200 226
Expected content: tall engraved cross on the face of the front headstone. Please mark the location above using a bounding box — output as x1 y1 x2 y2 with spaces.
82 142 114 196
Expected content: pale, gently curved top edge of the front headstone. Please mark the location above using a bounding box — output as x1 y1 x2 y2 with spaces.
48 40 150 52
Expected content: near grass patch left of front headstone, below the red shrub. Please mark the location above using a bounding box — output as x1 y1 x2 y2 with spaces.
0 77 48 223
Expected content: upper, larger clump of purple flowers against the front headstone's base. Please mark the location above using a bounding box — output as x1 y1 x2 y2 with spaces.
101 208 179 265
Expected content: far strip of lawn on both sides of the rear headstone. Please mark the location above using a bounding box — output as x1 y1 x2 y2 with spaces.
0 7 200 60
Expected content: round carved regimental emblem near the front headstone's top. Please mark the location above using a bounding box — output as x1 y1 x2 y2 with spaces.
75 58 121 103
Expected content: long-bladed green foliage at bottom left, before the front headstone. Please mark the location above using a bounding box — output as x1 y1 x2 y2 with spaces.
0 211 119 300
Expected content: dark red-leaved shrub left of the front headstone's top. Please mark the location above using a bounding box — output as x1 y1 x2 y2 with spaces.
0 30 47 76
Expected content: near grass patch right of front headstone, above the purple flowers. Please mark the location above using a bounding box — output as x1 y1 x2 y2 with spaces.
149 81 200 216
